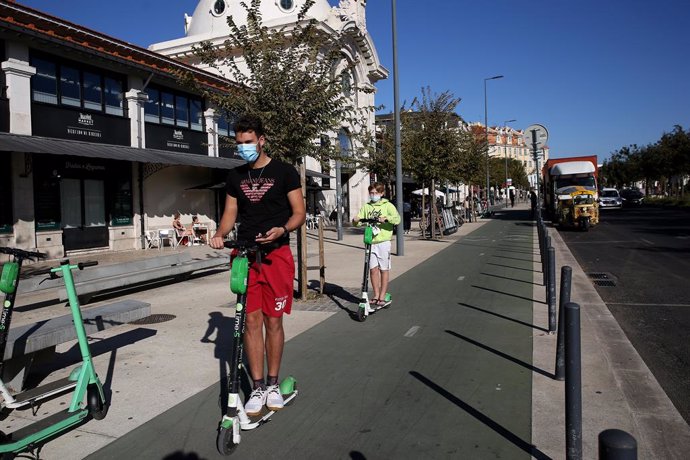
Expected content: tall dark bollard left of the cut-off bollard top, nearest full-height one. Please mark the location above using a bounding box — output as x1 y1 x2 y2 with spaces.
565 302 582 460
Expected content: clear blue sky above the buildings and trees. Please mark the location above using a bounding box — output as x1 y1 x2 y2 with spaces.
19 0 690 161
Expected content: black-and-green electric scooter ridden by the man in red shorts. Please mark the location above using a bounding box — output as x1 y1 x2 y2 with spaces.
216 241 297 455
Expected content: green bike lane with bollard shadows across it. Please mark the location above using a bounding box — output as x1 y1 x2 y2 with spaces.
88 213 544 460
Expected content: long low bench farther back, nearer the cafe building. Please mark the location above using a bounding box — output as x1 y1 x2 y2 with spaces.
18 252 230 304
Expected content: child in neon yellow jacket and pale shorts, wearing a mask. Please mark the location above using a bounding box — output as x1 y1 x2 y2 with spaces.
352 182 400 307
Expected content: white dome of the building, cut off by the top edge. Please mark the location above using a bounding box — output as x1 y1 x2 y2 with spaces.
186 0 331 37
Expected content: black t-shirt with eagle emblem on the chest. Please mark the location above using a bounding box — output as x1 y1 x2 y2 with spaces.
226 159 301 243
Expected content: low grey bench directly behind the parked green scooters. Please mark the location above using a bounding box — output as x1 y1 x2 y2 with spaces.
2 300 151 392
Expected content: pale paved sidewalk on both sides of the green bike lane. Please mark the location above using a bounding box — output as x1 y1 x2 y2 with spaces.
4 205 690 460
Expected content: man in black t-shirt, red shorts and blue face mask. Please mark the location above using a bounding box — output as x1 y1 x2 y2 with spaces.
210 116 306 416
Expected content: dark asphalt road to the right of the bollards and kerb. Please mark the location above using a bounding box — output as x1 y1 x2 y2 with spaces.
561 207 690 423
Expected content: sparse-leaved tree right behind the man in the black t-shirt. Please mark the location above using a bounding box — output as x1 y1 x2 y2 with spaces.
180 0 372 296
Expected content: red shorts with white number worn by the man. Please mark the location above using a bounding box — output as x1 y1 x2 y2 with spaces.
234 244 295 316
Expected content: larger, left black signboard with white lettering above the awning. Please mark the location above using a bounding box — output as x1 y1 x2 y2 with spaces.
31 103 131 145
